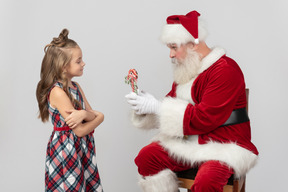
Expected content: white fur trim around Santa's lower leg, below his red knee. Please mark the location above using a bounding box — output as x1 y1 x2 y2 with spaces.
139 169 178 192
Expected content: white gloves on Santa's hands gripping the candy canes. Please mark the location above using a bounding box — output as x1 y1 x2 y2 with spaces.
125 91 161 115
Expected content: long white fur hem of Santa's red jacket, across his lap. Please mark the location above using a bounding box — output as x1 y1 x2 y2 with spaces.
154 135 258 177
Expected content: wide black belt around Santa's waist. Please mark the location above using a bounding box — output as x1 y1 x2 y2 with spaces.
220 108 250 127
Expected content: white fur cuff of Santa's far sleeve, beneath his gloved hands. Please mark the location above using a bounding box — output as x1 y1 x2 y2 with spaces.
131 112 159 130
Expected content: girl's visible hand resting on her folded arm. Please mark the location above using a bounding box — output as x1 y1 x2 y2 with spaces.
65 109 86 129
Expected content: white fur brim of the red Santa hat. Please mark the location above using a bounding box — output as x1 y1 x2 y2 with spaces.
160 21 207 45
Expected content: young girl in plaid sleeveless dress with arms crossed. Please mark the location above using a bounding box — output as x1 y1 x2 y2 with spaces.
36 29 104 192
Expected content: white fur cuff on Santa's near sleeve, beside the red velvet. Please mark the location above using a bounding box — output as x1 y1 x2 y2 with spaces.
159 97 189 137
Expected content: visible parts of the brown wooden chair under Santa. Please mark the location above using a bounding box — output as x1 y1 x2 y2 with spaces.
176 89 249 192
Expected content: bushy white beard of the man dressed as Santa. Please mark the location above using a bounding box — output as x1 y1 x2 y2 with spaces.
172 49 201 84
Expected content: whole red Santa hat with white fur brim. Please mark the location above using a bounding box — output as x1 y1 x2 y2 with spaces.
161 11 207 45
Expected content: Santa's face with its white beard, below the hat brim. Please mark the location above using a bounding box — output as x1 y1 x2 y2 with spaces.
168 45 200 84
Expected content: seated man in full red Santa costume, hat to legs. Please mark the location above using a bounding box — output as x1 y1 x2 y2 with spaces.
126 11 258 192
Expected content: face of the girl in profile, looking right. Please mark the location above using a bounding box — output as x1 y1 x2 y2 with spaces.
64 47 85 79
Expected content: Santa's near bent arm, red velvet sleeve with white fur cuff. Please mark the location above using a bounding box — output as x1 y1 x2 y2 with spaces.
159 63 245 137
